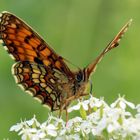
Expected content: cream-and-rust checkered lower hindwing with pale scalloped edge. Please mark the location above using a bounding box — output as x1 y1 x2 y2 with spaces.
12 61 68 110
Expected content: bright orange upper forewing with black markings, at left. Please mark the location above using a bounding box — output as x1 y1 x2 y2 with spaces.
0 12 72 76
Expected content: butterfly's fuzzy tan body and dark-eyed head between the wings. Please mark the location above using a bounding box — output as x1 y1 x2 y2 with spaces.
61 70 88 109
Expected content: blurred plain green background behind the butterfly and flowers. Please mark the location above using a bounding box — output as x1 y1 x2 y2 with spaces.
0 0 140 139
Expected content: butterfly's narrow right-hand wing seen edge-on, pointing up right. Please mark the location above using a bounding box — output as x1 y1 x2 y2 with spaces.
85 19 132 79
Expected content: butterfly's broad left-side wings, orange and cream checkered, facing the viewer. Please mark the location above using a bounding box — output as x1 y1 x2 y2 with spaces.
0 12 72 110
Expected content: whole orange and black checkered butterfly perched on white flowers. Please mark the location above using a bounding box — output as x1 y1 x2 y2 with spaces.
0 12 131 115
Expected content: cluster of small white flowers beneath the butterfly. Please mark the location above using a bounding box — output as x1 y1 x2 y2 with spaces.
10 96 140 140
